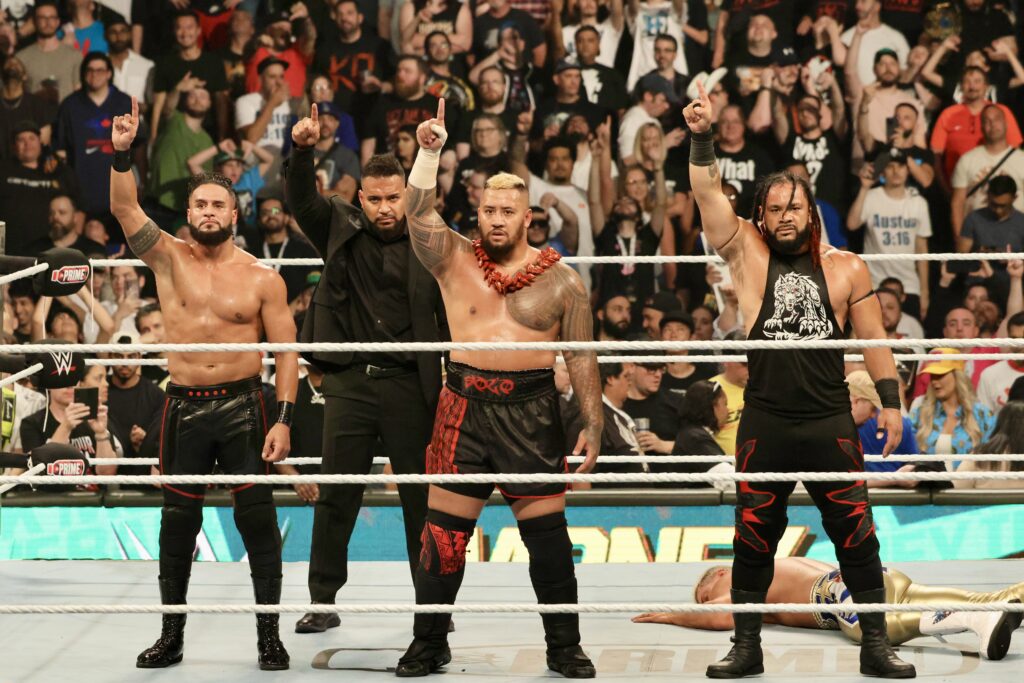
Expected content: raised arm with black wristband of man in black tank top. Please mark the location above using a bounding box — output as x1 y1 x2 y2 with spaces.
683 81 740 250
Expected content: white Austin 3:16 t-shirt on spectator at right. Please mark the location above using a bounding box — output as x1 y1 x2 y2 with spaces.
860 187 932 294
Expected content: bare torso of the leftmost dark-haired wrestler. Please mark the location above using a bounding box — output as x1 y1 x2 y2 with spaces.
142 222 275 386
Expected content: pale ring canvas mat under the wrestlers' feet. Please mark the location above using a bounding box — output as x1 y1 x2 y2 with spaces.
0 560 1024 683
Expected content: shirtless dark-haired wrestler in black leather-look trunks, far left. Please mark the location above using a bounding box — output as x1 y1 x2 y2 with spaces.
111 98 298 670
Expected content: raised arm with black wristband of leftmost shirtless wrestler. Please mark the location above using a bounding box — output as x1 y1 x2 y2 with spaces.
111 97 173 270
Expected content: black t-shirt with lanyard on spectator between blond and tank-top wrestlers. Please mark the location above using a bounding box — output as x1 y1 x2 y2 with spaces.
594 223 660 309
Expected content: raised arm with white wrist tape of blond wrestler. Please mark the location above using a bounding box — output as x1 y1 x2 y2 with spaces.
406 97 470 278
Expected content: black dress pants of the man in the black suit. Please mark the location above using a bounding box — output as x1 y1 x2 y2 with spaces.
309 369 434 603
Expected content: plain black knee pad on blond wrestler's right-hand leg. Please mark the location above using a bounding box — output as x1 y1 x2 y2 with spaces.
519 512 577 603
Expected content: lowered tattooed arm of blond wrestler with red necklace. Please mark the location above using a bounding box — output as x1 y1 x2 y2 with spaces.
551 264 604 472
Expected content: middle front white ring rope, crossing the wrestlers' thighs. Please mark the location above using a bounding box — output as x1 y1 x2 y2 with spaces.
0 471 1024 488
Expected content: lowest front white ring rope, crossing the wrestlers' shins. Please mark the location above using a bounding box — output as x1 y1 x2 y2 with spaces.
0 602 1024 614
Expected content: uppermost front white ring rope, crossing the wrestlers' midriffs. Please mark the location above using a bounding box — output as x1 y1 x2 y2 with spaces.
0 337 1024 361
